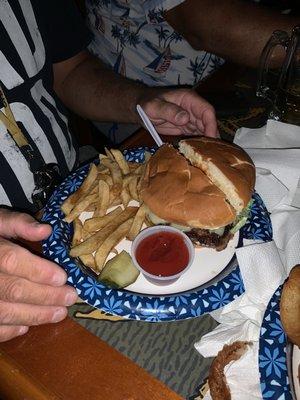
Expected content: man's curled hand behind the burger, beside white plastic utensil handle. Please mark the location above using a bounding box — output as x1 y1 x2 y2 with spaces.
140 89 218 137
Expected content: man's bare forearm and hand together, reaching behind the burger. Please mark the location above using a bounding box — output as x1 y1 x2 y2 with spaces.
53 52 217 136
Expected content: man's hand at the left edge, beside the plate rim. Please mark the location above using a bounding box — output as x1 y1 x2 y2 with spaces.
0 209 77 342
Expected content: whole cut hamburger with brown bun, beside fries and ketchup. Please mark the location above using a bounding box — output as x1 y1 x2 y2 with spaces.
140 137 255 250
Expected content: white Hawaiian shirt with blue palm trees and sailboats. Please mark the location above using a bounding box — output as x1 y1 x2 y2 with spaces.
86 0 223 86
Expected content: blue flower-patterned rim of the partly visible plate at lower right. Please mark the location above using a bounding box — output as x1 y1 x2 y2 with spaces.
259 286 292 400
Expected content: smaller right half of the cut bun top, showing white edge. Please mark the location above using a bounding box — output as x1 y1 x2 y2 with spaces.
179 136 255 213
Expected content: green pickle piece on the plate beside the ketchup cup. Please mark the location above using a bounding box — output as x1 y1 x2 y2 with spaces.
98 250 140 289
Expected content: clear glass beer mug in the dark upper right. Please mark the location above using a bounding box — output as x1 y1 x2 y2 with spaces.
256 26 300 125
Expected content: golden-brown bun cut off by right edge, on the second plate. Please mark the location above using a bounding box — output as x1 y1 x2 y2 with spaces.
280 264 300 347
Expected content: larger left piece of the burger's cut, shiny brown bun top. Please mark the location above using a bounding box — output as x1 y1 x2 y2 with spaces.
140 144 236 229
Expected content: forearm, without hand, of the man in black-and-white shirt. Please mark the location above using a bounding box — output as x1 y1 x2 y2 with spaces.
54 55 151 123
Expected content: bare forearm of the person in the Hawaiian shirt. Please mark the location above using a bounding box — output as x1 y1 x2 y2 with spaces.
166 0 299 67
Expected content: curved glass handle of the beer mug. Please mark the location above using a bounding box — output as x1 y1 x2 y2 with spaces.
256 31 290 103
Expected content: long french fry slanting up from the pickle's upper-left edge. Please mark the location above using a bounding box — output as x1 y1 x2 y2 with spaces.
95 218 133 272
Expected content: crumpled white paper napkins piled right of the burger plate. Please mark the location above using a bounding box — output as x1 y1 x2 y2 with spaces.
195 120 300 400
